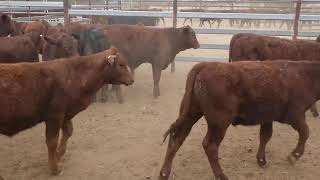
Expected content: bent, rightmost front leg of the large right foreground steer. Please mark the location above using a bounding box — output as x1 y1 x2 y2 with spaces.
288 114 309 164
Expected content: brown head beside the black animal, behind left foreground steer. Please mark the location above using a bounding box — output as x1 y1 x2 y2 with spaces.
42 32 79 61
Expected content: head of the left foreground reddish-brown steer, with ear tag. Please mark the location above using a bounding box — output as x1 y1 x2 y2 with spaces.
104 48 134 86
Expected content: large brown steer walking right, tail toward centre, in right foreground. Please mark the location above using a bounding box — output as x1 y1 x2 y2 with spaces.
159 60 320 180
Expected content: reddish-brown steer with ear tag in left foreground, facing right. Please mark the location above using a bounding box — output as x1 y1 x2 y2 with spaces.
0 48 133 175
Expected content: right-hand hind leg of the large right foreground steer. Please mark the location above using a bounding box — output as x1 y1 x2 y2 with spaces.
202 118 229 180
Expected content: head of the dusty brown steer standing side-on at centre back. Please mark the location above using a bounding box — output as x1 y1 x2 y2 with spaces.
178 26 200 49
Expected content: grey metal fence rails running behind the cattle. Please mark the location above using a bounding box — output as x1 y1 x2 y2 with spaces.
0 0 320 61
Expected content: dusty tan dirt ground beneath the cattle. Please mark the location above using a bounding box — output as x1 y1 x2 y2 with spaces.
0 19 320 180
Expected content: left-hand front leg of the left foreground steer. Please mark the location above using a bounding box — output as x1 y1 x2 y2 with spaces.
46 119 61 175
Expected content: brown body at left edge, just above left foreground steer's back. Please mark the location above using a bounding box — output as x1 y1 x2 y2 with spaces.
0 32 40 63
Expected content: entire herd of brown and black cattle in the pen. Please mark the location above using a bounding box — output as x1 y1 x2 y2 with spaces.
0 14 320 180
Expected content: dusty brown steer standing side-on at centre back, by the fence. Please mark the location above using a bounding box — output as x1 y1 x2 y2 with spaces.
105 25 199 97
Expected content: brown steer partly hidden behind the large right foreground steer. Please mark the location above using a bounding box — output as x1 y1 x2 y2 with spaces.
229 33 320 117
